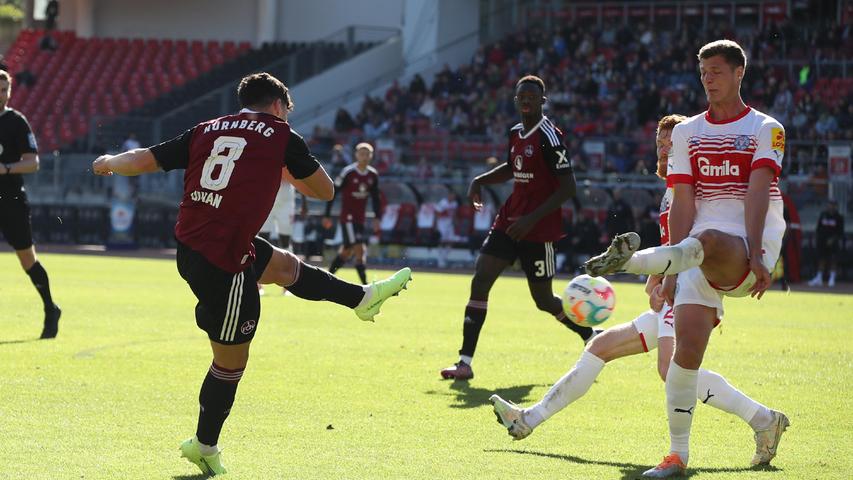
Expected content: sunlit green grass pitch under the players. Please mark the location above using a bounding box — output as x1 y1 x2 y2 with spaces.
0 253 853 480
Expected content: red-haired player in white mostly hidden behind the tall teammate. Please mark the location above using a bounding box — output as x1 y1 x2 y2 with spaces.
489 115 770 468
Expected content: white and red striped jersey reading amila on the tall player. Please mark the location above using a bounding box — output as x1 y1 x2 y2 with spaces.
667 107 785 245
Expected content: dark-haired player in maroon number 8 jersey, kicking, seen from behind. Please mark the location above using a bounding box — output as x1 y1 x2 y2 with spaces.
92 73 411 475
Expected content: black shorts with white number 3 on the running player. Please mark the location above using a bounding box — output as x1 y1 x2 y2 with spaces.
480 229 557 282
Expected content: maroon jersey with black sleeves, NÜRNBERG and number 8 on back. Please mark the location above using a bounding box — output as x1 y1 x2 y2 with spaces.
151 109 319 273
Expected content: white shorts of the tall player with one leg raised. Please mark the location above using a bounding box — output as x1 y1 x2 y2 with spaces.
675 233 782 319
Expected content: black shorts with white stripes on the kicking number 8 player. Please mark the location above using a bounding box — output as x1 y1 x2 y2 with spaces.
177 237 273 345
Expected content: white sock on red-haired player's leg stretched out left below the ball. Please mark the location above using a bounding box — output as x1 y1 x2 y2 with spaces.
524 350 604 428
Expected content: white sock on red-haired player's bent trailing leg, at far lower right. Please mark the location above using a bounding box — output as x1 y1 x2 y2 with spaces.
699 369 773 430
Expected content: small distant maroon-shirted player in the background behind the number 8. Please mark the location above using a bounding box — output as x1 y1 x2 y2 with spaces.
326 142 380 283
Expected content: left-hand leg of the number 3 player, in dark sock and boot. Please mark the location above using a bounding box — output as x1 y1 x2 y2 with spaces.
441 253 510 380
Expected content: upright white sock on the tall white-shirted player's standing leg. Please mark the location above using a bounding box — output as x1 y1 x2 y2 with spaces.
666 360 699 464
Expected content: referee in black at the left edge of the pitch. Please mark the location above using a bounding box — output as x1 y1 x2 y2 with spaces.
0 70 62 338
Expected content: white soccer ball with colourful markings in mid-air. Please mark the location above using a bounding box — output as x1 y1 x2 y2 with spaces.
563 275 616 327
